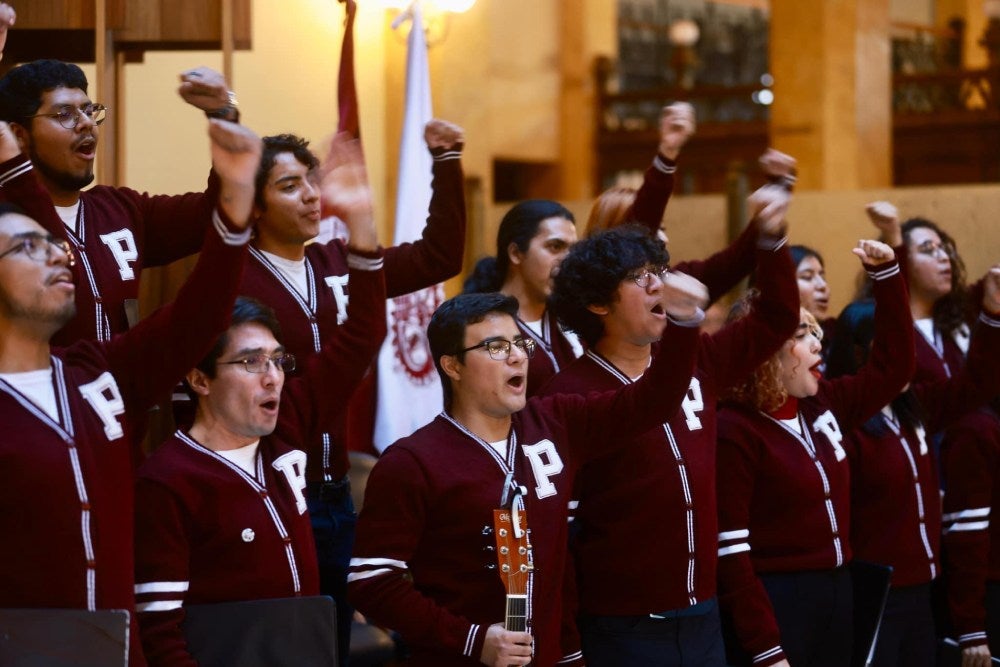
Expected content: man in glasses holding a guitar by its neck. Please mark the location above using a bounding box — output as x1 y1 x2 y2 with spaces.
348 272 707 667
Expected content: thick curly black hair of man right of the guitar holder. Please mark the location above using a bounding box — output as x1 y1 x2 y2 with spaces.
548 224 670 346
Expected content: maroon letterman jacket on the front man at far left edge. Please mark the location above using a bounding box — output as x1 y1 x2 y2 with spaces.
0 210 249 665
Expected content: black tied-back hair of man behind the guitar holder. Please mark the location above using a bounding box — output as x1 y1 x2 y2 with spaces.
462 199 576 293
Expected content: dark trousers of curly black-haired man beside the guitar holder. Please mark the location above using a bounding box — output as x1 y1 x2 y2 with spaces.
578 598 726 667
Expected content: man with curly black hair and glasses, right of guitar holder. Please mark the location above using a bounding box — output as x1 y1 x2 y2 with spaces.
542 185 799 667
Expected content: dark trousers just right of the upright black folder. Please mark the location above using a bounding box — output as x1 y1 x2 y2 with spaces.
872 583 937 667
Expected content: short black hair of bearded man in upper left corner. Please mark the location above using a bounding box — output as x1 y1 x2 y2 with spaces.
0 60 87 127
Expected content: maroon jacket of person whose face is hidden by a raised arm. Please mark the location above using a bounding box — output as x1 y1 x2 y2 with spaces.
844 313 1000 586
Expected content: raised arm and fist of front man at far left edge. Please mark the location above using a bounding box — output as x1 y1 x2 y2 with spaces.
107 120 261 416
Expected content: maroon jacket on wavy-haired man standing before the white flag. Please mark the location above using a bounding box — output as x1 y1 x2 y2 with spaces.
235 145 465 482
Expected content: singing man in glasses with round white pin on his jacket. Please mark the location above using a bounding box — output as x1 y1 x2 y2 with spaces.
135 149 386 667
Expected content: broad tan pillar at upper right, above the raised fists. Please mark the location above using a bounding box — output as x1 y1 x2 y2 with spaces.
770 0 892 189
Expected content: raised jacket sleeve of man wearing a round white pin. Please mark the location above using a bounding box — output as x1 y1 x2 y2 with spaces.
276 251 386 448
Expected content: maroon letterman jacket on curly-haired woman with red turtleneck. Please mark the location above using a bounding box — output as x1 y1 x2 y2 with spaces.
717 261 913 665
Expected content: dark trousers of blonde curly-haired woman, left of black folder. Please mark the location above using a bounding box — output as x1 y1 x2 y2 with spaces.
744 568 854 667
